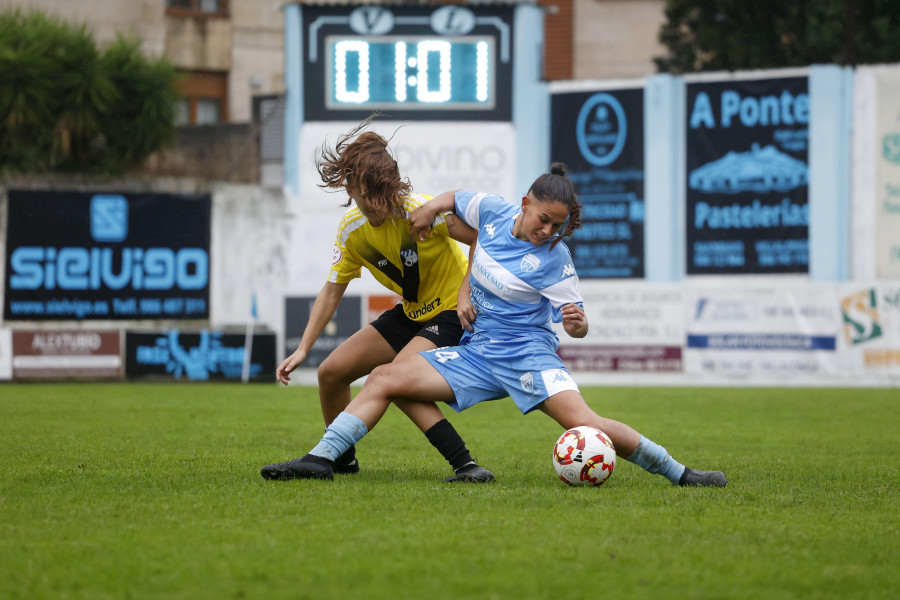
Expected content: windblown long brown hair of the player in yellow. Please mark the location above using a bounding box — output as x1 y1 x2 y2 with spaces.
316 115 412 218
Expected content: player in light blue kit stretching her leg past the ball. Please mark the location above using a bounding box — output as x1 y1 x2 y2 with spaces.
284 163 728 487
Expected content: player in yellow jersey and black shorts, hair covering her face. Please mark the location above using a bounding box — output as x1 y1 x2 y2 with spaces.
261 117 494 482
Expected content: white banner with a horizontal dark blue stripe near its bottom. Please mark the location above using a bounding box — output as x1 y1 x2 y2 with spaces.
684 285 842 382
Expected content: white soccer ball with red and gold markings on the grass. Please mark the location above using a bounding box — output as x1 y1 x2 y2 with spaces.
553 425 616 486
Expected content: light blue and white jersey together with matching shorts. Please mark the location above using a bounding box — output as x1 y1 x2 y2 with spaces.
420 190 583 414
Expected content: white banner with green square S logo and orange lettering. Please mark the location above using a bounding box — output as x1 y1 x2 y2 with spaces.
839 282 900 377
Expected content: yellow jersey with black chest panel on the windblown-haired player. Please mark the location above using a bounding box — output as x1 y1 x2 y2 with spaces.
328 194 468 321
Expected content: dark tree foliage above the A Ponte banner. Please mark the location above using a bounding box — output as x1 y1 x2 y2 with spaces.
655 0 900 73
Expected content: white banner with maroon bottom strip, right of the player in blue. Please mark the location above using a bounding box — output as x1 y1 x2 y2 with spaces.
556 284 684 373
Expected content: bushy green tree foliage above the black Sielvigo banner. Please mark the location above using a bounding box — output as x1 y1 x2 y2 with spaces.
0 10 178 173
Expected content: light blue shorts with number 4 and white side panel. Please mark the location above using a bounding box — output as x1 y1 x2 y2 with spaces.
419 338 578 414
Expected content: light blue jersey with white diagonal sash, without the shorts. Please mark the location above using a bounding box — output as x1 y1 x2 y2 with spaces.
456 190 583 350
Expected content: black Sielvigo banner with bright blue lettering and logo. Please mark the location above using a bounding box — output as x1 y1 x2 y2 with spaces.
3 190 211 321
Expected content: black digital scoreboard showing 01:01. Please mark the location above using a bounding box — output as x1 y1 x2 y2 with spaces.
303 5 512 121
